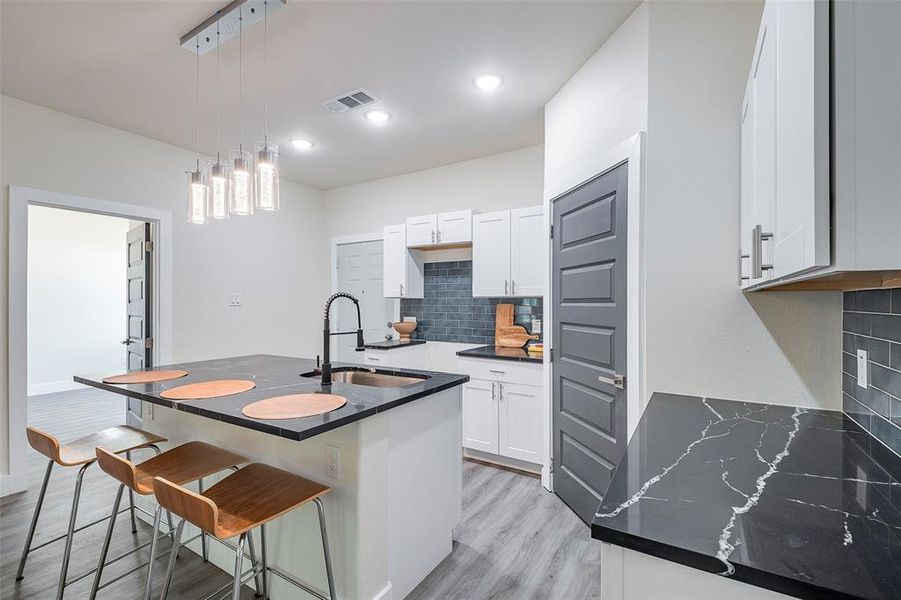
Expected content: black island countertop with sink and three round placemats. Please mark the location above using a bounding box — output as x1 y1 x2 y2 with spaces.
74 354 469 440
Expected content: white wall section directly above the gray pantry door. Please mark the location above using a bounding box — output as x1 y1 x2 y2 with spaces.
544 2 648 198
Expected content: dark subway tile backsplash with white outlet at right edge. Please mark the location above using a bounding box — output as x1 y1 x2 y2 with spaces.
842 289 901 455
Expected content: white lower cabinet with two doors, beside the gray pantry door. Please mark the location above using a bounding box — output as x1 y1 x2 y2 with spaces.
463 379 541 464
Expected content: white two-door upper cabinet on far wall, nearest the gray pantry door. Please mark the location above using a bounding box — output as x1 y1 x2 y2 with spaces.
472 206 547 297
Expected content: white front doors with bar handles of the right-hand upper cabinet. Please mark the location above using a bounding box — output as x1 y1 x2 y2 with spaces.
739 0 829 287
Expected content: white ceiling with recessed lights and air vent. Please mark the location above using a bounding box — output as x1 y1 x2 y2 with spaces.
0 0 637 189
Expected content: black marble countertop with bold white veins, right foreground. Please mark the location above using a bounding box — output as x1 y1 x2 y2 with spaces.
591 394 901 599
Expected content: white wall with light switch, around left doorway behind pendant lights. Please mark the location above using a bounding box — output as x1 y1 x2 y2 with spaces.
0 97 329 472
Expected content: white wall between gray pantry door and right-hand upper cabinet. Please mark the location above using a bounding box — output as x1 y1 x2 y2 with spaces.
645 1 841 409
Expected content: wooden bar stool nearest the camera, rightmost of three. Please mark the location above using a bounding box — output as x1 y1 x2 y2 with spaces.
153 463 335 600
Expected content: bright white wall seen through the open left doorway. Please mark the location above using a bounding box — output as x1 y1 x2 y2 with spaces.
28 206 129 396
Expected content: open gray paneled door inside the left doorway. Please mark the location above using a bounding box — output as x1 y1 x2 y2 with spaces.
122 223 153 427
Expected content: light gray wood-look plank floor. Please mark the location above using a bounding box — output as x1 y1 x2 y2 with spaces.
0 389 601 600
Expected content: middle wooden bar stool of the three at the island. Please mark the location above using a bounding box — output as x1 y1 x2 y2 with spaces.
90 442 247 600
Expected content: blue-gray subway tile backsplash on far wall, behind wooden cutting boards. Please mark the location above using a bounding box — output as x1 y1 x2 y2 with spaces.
400 260 543 345
